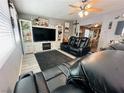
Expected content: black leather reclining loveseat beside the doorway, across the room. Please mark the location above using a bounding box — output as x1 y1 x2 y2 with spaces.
61 36 90 57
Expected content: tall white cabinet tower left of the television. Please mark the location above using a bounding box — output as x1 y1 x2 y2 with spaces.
19 19 33 54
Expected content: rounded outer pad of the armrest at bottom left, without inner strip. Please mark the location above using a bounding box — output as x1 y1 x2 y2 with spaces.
14 72 38 93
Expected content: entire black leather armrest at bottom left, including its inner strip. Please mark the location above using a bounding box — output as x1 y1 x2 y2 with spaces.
14 72 49 93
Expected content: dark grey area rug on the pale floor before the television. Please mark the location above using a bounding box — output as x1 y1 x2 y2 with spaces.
35 50 73 71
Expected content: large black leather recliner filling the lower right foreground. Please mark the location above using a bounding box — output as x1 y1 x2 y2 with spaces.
53 50 124 93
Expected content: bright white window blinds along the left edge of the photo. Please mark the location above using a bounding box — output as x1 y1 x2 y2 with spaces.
0 0 15 68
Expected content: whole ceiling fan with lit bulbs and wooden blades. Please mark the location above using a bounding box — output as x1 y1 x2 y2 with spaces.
69 0 103 17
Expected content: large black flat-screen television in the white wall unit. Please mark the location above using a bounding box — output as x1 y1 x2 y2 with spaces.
32 27 56 42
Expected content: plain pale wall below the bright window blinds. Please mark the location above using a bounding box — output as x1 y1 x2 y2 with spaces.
0 47 21 93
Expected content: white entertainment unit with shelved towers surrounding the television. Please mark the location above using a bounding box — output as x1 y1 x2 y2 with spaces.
19 19 63 54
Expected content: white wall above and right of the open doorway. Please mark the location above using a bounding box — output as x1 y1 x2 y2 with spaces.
78 9 124 48
